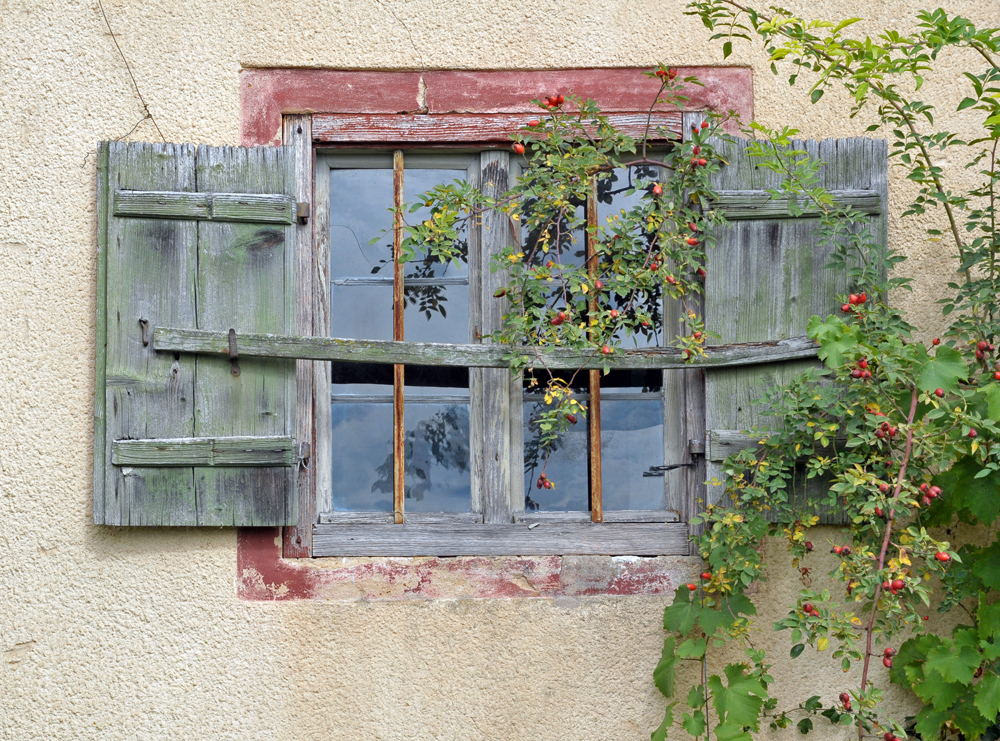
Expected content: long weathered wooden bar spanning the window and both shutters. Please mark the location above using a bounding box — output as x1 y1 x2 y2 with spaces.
153 327 818 370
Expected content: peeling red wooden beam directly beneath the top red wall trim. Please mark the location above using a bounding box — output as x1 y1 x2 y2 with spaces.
313 111 681 145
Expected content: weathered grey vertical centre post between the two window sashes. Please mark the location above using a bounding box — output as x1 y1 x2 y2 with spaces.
479 152 513 525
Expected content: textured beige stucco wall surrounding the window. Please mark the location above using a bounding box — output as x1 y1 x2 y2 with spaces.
0 0 1000 741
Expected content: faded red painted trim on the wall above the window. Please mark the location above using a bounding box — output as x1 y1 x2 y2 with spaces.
239 67 753 146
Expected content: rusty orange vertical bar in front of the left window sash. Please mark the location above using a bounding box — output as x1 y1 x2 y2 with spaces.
392 150 406 525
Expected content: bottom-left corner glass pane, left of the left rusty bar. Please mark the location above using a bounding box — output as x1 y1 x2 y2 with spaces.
331 402 392 512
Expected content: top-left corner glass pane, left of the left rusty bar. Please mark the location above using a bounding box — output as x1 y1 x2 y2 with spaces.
330 169 392 278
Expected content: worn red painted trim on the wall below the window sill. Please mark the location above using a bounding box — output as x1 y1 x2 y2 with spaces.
236 528 696 602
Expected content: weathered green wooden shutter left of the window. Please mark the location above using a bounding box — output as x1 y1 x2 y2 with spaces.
94 142 298 526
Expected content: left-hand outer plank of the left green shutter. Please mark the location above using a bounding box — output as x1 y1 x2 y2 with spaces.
102 142 197 525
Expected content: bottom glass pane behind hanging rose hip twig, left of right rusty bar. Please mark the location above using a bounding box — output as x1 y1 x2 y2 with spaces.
524 394 590 512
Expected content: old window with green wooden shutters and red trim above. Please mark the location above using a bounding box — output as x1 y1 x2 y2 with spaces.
94 68 887 556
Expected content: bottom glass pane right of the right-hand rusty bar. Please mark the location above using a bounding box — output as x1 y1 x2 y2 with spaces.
601 371 666 510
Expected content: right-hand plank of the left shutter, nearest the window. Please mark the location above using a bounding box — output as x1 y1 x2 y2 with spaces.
191 146 297 525
